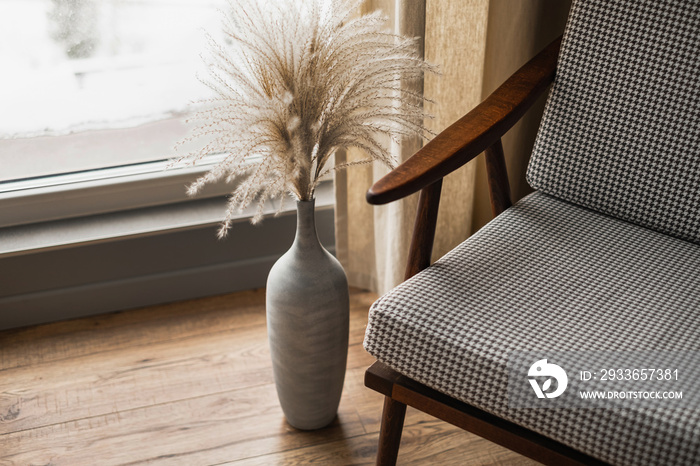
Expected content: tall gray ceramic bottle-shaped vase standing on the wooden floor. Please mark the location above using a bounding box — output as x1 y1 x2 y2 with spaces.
266 200 350 430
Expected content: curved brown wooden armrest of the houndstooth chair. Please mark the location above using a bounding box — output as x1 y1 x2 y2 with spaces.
367 37 561 204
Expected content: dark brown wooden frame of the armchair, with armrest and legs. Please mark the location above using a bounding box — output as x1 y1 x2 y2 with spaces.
365 38 604 465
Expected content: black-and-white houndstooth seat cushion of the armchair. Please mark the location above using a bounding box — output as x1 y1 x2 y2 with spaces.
364 192 700 464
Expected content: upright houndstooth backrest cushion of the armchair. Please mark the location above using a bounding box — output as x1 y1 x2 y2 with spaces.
527 0 700 243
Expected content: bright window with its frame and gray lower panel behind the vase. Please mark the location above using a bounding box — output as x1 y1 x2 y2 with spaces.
0 0 333 328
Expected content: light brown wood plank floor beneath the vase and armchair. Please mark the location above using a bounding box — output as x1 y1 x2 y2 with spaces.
0 290 534 466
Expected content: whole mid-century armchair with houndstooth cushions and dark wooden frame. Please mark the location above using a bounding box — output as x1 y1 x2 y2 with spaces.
364 0 700 464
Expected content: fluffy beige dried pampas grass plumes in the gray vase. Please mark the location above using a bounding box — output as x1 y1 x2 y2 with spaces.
174 0 433 236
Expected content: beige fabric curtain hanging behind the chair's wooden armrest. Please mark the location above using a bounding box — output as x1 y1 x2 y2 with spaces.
335 0 568 294
